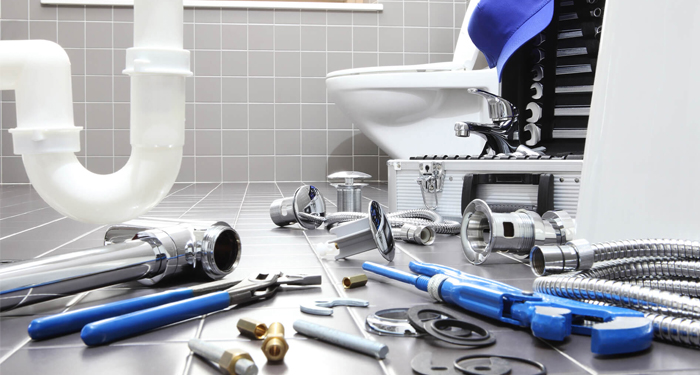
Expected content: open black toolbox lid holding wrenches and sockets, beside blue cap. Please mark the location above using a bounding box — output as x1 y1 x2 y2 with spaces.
502 0 605 154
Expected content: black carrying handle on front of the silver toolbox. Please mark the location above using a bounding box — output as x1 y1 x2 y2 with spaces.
461 173 554 215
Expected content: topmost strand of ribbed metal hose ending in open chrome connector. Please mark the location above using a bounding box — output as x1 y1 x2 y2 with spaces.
530 239 700 276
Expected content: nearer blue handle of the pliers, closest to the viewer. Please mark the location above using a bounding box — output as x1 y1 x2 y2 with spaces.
80 292 230 346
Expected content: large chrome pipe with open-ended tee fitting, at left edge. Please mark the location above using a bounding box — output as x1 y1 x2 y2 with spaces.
0 221 241 311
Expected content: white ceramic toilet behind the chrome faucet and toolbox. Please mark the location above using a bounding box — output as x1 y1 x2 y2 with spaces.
326 0 500 159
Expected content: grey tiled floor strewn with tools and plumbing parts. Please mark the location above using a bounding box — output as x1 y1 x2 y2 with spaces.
0 183 700 375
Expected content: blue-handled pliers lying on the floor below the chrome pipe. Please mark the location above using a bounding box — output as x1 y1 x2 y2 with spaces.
28 272 321 346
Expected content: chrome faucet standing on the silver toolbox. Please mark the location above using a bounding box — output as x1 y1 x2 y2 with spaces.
454 88 541 156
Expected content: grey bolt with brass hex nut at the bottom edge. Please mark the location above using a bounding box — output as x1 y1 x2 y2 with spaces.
187 339 258 375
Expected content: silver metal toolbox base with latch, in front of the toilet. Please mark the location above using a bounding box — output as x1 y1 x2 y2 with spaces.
387 155 583 220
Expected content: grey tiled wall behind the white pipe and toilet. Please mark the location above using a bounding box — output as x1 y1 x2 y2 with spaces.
0 0 466 183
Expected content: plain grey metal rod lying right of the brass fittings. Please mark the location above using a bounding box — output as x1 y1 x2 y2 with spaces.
294 320 389 359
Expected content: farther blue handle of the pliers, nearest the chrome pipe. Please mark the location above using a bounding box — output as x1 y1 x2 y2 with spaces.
27 289 194 340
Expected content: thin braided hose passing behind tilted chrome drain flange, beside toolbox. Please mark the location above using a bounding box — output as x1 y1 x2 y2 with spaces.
299 210 460 234
